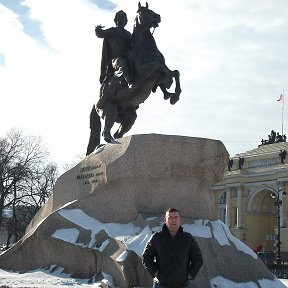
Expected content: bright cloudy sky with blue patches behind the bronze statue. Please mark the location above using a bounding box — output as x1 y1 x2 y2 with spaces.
0 0 288 169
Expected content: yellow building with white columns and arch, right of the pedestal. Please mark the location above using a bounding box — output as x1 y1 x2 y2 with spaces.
211 142 288 255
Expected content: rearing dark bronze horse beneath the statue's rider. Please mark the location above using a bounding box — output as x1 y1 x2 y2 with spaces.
86 2 181 155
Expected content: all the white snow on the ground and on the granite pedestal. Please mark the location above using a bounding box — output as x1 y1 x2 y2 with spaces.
0 209 288 288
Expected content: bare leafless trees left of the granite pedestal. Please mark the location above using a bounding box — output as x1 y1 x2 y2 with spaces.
0 129 58 242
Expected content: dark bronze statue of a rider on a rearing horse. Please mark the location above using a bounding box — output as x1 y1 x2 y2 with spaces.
86 2 181 155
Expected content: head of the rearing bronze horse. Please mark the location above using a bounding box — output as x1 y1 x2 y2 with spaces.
135 2 161 29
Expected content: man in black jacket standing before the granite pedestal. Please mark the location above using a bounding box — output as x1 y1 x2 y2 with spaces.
142 208 203 288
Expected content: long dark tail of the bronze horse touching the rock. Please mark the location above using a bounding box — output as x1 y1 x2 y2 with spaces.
86 105 101 156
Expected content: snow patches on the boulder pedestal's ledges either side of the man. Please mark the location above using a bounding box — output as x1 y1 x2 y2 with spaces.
51 209 257 259
